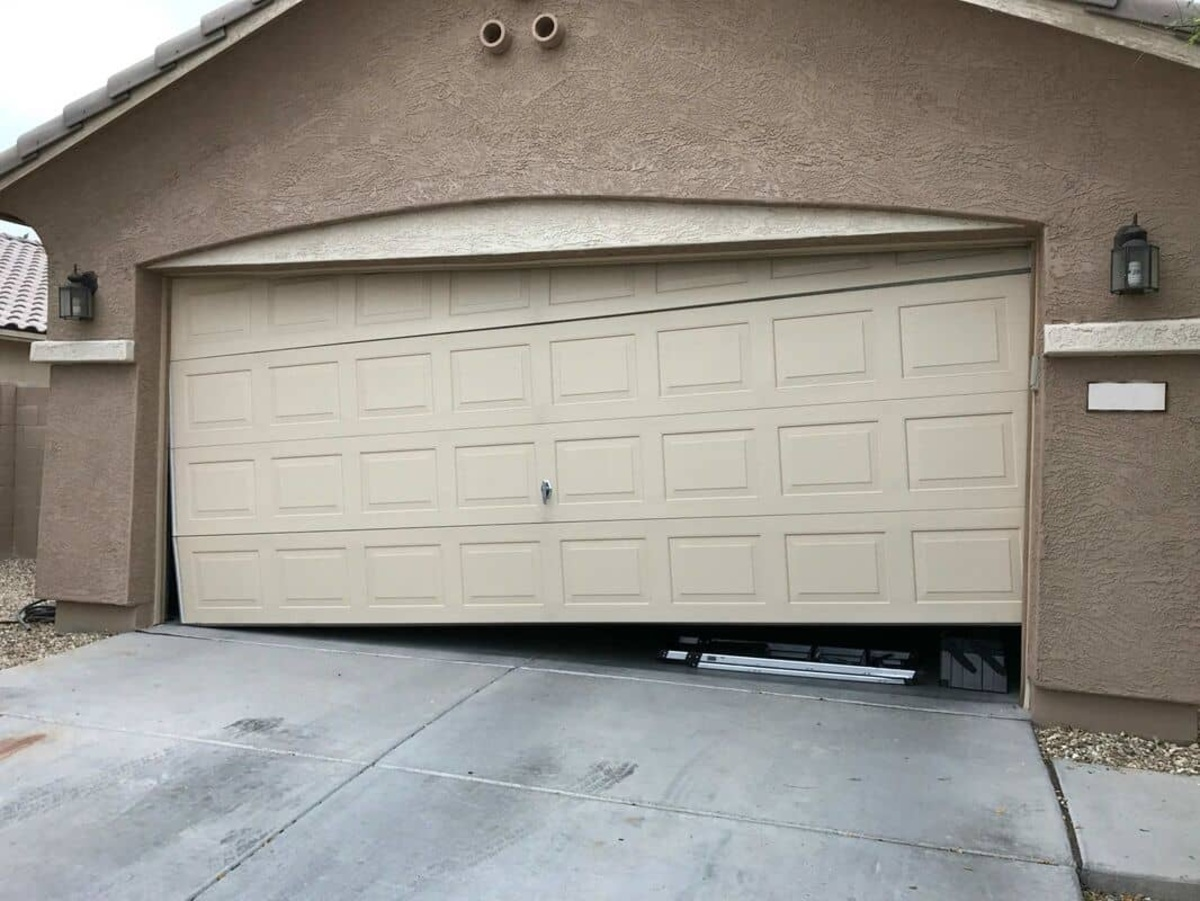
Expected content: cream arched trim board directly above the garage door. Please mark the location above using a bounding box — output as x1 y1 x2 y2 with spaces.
151 198 1014 272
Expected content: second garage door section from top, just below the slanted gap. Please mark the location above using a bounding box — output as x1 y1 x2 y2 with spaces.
172 277 1028 448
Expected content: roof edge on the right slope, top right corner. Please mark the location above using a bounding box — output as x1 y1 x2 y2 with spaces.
961 0 1200 68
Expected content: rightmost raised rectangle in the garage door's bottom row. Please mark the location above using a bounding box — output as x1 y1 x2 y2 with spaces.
912 529 1021 603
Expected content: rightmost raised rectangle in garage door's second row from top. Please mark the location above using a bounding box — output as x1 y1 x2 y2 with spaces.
900 298 1008 378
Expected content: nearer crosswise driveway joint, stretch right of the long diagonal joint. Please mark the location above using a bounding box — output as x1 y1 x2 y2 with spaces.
373 763 1073 869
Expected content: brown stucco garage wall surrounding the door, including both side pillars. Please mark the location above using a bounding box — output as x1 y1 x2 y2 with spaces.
0 0 1200 719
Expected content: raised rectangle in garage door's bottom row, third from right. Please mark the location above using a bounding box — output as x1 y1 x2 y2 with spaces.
670 535 760 603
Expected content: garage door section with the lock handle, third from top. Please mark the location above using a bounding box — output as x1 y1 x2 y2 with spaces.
174 392 1027 535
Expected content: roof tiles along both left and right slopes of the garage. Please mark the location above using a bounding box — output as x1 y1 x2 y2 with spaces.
0 0 1200 187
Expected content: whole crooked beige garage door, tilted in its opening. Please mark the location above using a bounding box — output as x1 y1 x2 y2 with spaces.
170 251 1030 624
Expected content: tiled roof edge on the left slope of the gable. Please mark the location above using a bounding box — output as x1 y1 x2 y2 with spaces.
0 0 304 191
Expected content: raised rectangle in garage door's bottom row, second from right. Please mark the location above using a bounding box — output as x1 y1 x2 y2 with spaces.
787 533 887 603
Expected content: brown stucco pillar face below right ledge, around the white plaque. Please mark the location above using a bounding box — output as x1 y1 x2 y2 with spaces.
1036 356 1200 704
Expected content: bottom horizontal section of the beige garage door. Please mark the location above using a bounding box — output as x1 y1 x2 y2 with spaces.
179 510 1024 624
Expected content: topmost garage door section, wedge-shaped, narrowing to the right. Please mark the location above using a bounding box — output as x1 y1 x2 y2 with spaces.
172 247 1030 360
